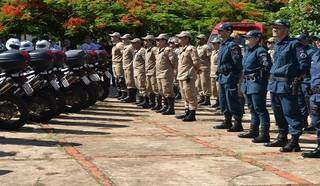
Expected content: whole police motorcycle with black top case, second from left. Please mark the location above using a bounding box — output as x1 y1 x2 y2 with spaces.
14 39 60 122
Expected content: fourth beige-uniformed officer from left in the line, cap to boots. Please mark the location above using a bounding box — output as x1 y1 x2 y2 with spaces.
143 35 159 110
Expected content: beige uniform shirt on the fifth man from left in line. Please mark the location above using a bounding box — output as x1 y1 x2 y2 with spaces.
156 47 177 78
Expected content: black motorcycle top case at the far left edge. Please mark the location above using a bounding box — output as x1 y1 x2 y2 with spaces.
0 50 30 74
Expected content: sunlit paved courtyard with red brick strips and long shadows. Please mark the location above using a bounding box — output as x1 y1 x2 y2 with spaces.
0 98 320 186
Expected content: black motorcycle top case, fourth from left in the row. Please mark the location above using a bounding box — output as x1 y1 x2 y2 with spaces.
66 50 87 68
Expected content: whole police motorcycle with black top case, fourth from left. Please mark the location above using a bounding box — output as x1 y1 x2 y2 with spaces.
65 50 99 112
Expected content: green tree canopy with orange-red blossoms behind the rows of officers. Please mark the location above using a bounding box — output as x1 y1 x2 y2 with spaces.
0 0 292 43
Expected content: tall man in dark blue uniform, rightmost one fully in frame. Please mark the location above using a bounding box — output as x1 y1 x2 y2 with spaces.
265 19 310 152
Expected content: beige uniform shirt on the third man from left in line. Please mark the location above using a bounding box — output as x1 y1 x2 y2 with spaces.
133 47 146 76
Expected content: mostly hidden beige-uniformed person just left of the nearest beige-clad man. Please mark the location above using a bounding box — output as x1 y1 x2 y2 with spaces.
168 37 181 100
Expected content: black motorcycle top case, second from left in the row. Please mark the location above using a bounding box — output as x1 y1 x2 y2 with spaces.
30 50 54 72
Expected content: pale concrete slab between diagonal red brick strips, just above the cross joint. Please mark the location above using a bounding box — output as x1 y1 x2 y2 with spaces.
70 136 219 157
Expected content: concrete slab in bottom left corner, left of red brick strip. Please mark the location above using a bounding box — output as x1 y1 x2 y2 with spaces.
0 159 99 186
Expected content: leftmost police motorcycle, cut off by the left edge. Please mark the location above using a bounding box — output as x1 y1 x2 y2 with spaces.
0 39 28 130
